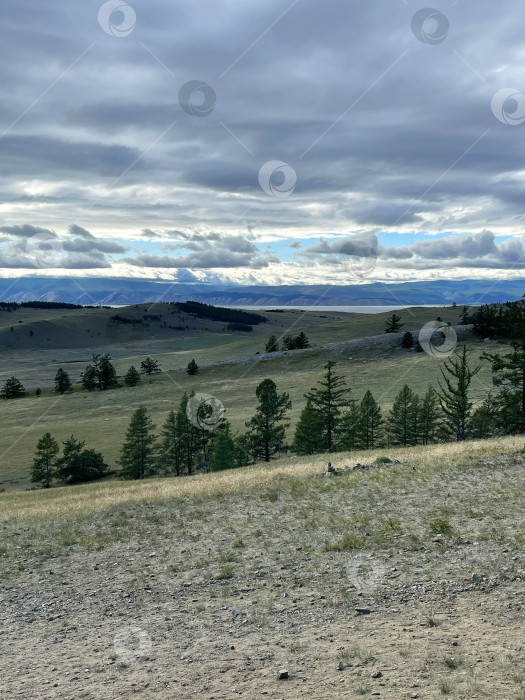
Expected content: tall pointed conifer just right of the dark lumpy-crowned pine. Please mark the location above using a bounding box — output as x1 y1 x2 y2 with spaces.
305 360 350 452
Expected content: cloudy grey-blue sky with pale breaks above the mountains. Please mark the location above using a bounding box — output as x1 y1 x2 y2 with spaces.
0 0 525 284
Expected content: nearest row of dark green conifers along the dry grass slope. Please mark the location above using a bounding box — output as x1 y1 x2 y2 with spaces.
32 341 525 486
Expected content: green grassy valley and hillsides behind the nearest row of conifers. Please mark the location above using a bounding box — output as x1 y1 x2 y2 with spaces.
0 307 508 489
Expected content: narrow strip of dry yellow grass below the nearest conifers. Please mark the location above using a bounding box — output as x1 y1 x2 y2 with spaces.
0 436 523 521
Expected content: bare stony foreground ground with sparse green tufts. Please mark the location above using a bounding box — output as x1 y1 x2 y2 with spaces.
0 451 525 700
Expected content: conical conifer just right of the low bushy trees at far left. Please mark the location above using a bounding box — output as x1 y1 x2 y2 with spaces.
118 406 156 479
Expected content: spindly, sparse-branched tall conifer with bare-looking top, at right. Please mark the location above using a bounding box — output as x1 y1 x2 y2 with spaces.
437 345 481 440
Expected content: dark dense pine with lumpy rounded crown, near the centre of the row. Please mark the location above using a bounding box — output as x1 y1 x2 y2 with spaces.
246 379 292 462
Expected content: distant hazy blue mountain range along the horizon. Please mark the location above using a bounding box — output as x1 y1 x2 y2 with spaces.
0 277 525 306
